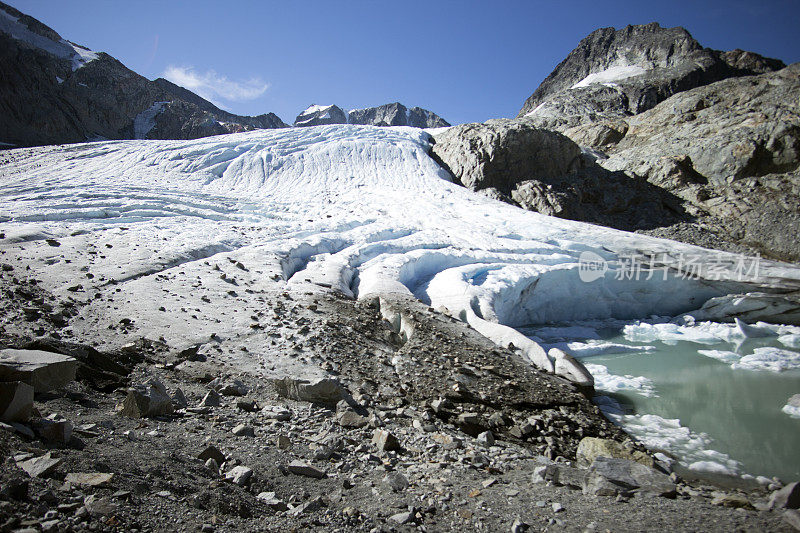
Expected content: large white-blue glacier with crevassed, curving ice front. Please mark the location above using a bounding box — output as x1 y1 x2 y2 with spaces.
0 125 800 371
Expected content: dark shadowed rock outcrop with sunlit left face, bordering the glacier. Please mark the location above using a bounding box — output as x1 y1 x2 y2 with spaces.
431 119 685 229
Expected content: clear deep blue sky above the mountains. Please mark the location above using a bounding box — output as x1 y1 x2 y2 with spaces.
6 0 800 123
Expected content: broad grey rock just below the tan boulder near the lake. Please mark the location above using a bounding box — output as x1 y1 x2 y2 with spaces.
583 457 676 498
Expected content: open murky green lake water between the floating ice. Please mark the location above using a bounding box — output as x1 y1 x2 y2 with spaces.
534 327 800 481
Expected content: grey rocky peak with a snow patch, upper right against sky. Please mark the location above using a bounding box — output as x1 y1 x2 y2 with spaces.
518 23 785 146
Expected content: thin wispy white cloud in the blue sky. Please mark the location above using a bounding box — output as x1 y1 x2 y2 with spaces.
162 65 269 102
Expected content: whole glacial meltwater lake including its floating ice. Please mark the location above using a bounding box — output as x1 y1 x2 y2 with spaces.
522 320 800 482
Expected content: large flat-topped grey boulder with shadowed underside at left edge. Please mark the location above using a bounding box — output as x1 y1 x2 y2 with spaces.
0 348 78 392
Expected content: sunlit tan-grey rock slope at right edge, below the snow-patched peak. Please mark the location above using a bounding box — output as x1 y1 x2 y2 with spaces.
601 63 800 261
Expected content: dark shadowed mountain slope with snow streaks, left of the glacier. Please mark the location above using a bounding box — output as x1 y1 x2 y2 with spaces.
0 2 285 146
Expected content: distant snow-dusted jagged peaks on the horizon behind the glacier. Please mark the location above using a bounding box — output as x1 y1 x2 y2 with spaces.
294 102 450 128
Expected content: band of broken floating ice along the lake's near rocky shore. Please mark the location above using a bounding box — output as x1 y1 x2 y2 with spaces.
606 413 741 475
